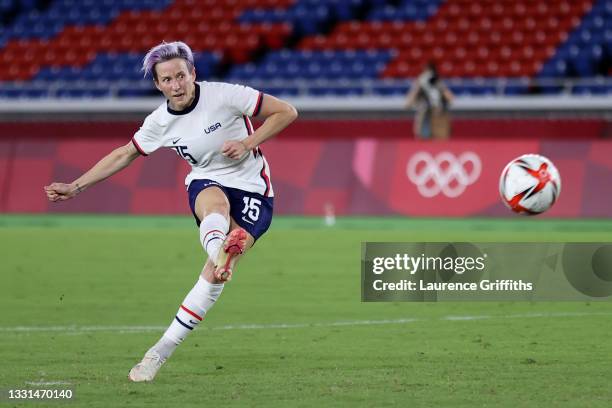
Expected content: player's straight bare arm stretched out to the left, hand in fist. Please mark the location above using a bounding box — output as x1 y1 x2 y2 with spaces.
44 141 139 201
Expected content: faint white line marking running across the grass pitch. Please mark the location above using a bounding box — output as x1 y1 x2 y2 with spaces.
0 312 612 335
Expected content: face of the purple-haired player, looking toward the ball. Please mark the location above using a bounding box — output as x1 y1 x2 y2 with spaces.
155 58 195 111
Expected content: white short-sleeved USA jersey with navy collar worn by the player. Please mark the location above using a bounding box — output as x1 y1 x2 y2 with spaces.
132 81 274 197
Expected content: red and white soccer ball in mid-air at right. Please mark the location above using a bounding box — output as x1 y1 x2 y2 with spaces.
499 154 561 215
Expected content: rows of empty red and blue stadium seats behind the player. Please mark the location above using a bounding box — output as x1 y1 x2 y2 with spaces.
0 0 612 98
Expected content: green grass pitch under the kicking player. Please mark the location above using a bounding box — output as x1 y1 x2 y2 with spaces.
0 215 612 408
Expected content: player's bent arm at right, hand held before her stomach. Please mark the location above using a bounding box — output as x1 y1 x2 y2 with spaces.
221 94 298 160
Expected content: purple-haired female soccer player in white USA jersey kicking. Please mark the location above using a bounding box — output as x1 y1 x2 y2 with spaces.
45 41 297 382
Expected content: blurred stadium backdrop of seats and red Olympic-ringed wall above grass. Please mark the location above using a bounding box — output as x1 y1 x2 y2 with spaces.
0 0 612 217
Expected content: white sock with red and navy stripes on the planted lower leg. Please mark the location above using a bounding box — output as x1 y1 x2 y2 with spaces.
153 276 224 358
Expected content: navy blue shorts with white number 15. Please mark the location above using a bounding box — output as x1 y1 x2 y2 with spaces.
187 179 274 240
